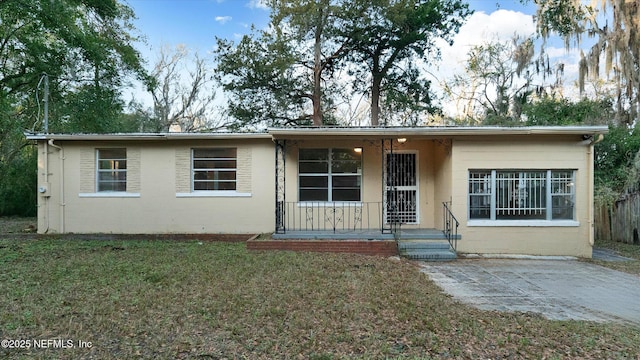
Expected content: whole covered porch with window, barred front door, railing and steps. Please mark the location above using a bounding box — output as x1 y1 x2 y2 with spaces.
270 128 460 258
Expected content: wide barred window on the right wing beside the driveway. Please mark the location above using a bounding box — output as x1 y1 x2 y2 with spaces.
469 170 575 220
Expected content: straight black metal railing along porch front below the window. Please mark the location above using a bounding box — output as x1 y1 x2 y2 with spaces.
276 201 383 233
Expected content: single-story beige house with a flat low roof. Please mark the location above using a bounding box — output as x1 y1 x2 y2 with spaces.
27 126 607 257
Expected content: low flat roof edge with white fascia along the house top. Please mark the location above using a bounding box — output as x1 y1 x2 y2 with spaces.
25 126 608 141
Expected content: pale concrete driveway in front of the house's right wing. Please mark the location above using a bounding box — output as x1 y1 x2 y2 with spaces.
421 259 640 325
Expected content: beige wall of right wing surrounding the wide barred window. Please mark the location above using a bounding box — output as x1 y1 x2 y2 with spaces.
451 136 593 257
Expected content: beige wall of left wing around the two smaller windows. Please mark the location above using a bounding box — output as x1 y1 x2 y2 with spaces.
38 139 275 233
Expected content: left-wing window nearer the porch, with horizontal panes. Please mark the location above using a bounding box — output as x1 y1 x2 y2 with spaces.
191 148 237 191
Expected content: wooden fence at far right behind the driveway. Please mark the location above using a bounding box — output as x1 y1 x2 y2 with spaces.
594 192 640 244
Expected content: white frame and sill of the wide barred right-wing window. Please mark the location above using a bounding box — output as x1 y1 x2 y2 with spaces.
467 169 580 226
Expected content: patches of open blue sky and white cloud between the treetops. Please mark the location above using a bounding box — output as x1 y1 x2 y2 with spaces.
126 0 568 113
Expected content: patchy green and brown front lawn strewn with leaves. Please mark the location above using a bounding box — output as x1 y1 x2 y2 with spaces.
0 239 640 359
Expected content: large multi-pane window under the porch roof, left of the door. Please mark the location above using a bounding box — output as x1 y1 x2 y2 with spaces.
298 149 362 201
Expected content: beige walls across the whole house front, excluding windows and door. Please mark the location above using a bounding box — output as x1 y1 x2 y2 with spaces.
38 131 593 257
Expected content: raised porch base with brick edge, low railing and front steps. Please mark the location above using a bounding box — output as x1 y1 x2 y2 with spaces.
264 203 461 261
